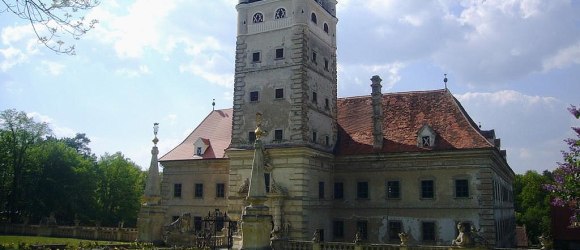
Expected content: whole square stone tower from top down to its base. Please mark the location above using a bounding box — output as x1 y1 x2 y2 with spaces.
227 0 338 239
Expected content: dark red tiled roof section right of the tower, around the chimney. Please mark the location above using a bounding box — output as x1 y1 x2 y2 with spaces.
337 89 493 155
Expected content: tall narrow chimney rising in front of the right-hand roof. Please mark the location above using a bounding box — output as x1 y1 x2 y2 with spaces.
371 76 384 150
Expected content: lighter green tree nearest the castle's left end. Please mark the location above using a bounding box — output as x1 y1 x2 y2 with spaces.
96 152 145 226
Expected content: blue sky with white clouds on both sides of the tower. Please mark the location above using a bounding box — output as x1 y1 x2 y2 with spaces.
0 0 580 174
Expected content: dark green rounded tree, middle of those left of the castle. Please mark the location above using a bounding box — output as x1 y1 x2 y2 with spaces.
26 140 96 224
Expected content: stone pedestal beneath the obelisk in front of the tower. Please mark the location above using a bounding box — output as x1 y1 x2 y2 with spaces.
242 205 272 250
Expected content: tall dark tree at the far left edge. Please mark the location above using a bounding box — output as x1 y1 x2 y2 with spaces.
0 109 51 221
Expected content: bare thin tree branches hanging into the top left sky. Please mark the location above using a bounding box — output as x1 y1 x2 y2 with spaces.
0 0 99 55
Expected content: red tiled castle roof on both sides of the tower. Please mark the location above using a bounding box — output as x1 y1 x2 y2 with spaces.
159 90 494 162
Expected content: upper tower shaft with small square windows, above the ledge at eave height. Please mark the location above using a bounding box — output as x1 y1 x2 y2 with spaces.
232 0 338 152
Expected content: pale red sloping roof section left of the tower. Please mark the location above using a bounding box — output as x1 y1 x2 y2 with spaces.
159 109 233 162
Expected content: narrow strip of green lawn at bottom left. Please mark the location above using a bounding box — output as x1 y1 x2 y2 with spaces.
0 235 128 249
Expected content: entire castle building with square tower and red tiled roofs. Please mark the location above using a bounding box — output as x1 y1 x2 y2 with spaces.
140 0 515 247
